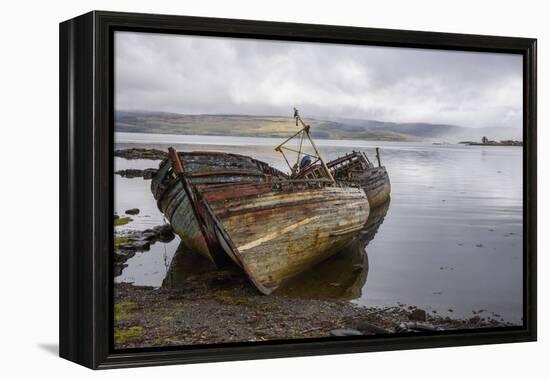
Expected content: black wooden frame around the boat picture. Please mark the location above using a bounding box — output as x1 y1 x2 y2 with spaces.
59 11 537 369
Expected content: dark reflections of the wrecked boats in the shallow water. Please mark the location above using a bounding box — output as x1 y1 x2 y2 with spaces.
162 200 390 300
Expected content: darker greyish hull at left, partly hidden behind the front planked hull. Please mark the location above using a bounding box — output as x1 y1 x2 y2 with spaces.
151 152 287 267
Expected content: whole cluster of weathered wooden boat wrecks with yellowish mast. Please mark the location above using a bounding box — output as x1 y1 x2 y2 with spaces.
151 109 389 294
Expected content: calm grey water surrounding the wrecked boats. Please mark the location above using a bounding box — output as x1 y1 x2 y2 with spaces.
115 133 523 323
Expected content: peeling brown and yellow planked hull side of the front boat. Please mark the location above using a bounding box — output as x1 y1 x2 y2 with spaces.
198 180 370 294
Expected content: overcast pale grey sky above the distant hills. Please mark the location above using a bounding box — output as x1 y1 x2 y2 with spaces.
115 32 522 129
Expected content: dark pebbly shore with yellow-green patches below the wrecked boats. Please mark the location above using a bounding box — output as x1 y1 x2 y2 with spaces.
114 260 508 349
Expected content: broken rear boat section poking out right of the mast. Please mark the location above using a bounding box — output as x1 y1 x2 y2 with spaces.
327 148 391 208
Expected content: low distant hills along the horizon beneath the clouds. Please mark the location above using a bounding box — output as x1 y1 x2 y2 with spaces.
115 111 521 142
